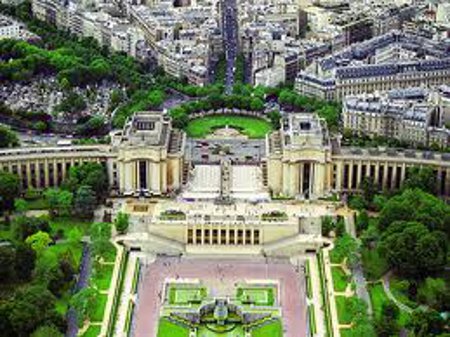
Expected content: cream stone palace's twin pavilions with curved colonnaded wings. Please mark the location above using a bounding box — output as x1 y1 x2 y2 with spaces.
0 112 450 199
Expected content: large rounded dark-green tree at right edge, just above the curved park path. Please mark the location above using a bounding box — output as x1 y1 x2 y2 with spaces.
379 221 447 279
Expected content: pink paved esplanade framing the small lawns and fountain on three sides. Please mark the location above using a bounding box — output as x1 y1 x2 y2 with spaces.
133 257 307 337
